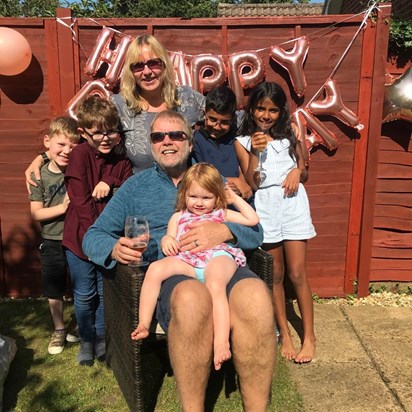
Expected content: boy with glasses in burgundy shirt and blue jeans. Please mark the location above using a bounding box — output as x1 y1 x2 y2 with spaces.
62 96 132 366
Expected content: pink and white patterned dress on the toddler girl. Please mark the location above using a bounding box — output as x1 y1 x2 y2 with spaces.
176 209 246 268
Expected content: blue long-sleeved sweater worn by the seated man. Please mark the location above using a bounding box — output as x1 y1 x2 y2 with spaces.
83 164 263 269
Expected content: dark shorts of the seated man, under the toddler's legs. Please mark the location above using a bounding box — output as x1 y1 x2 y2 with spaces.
156 266 260 332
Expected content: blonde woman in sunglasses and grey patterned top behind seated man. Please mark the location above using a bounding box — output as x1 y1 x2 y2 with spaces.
112 34 205 173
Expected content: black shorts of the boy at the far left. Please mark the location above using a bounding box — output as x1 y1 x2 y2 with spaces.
39 239 67 299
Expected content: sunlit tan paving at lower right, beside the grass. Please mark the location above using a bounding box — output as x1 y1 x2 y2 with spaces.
284 303 412 412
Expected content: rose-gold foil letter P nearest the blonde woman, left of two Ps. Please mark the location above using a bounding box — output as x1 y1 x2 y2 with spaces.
190 54 226 93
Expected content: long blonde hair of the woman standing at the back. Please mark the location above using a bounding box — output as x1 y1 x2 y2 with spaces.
120 34 179 113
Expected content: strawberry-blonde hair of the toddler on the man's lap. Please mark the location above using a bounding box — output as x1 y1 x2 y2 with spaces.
176 163 227 210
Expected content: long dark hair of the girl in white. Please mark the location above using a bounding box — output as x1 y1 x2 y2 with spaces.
239 82 298 162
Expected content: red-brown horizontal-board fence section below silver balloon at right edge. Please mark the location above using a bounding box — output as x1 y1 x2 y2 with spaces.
370 121 412 282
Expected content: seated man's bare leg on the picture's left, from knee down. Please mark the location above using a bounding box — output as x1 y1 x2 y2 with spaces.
168 280 213 412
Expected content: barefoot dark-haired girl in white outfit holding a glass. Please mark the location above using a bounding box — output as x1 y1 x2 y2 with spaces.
235 82 316 363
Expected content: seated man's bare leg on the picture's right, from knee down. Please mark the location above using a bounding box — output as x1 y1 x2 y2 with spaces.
229 279 276 412
